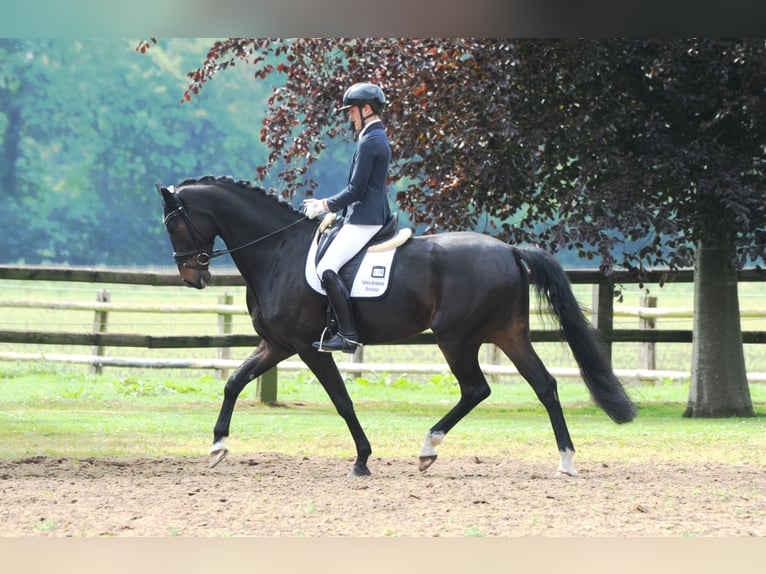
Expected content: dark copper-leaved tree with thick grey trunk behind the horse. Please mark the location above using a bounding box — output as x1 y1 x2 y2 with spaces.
146 38 766 417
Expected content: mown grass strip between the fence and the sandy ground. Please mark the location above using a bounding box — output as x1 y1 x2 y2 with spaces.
0 363 766 464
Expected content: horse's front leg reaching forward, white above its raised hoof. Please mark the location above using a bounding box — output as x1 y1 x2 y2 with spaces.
210 340 292 468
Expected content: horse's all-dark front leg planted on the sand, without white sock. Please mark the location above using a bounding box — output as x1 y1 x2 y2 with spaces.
300 349 372 476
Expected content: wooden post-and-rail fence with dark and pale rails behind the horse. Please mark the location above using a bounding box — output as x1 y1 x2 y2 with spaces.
0 265 766 402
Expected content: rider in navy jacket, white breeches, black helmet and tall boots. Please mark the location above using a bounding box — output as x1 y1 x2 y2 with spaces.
304 82 391 353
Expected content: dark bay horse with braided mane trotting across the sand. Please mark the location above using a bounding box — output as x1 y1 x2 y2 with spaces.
156 176 636 476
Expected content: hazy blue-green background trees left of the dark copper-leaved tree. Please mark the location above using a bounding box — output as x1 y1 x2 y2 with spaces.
0 39 272 266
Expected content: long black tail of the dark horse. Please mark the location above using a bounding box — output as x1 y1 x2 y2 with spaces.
514 247 636 423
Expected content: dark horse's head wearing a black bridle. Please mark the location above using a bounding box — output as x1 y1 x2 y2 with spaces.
157 184 215 289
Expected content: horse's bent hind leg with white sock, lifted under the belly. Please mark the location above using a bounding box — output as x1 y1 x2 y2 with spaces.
419 340 490 471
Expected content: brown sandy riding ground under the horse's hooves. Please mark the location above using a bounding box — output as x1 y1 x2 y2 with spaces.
0 453 766 537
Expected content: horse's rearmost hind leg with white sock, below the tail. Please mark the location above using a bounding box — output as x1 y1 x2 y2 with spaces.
493 335 577 476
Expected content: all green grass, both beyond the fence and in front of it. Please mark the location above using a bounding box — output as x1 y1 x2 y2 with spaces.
0 281 766 464
